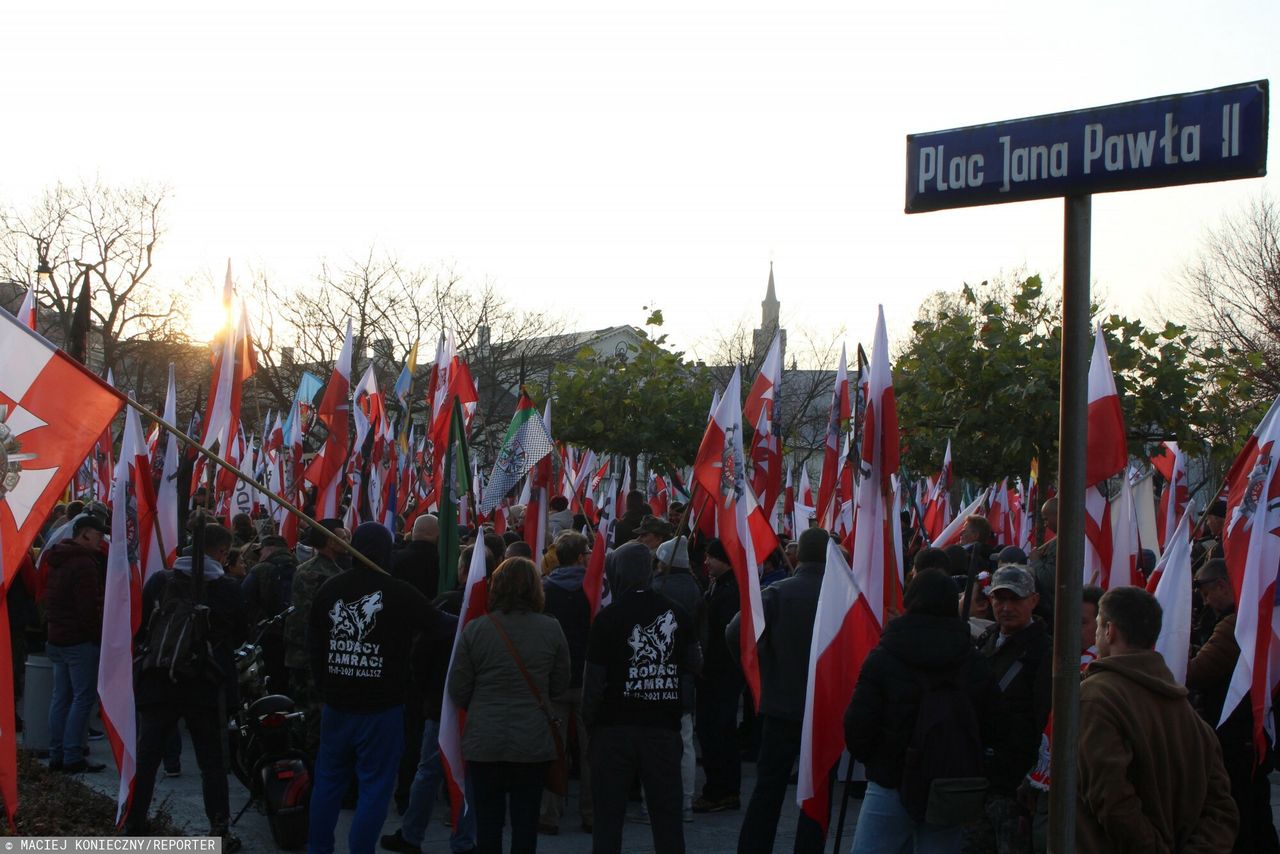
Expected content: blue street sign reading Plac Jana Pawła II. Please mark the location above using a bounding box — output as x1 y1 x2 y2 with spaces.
906 81 1268 214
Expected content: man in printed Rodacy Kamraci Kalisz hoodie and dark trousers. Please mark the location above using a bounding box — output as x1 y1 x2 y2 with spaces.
582 543 701 854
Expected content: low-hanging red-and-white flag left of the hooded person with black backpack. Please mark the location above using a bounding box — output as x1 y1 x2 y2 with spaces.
796 542 881 830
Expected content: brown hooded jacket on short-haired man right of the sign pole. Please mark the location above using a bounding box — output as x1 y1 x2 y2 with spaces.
1075 649 1238 854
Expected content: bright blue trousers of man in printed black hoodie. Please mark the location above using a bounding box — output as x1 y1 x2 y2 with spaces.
307 705 404 854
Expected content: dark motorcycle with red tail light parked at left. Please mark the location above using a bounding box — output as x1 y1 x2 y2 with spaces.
228 606 312 850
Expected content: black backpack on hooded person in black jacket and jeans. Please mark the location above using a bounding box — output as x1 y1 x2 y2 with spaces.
899 662 987 827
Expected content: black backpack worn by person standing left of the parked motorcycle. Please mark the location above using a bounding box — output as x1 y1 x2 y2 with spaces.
138 572 212 682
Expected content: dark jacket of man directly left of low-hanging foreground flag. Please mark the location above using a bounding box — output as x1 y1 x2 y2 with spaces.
726 562 824 723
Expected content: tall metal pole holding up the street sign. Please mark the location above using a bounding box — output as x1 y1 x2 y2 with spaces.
1048 195 1093 854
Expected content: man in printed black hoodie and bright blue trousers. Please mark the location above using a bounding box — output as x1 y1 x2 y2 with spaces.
307 522 440 854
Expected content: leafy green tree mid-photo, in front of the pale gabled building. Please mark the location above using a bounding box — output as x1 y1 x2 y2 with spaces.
535 310 712 469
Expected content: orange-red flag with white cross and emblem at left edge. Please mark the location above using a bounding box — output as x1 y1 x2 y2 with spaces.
0 312 124 584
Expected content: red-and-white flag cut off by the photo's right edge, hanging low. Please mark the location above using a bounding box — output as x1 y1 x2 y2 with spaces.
1219 398 1280 757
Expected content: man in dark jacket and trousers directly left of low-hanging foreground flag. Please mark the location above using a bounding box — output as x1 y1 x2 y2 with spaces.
726 528 831 854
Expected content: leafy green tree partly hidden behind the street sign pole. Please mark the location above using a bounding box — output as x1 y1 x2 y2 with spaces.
893 275 1233 483
